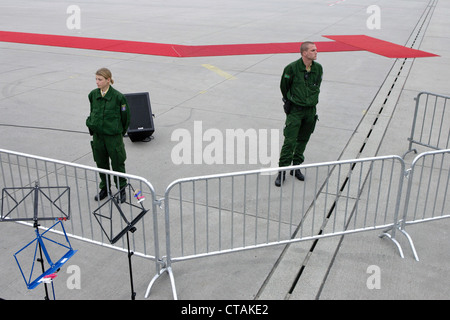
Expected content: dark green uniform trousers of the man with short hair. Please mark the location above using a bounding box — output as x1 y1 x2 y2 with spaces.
278 107 318 167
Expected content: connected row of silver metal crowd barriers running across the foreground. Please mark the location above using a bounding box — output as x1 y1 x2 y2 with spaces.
0 149 450 299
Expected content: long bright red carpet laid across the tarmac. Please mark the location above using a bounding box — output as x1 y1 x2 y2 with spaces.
0 31 434 58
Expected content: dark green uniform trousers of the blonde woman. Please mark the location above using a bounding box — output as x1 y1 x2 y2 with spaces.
91 133 127 190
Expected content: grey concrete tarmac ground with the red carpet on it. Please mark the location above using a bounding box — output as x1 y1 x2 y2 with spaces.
0 0 450 300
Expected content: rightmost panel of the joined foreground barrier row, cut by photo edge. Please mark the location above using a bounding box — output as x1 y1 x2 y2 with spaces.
400 149 450 261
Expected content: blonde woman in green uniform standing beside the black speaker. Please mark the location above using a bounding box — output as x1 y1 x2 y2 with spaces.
86 68 130 202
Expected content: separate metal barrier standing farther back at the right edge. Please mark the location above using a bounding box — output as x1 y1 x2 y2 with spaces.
403 92 450 157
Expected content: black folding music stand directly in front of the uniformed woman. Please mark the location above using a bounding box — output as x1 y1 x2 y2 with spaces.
93 184 148 300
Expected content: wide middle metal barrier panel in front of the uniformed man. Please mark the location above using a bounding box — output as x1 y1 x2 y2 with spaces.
165 156 404 263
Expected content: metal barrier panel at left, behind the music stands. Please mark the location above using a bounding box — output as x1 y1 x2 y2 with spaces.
0 149 168 298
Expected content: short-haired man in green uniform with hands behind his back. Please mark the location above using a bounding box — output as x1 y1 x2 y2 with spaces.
275 41 323 187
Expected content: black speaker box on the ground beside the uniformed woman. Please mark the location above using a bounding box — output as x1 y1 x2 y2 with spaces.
124 92 155 142
